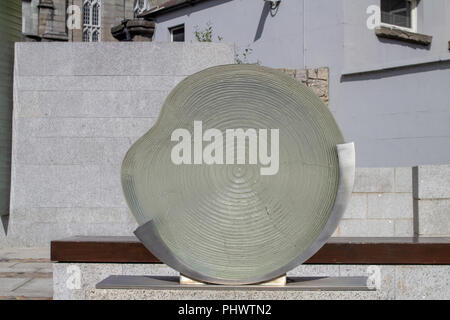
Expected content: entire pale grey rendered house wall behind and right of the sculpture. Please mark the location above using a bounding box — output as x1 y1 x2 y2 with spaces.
151 0 450 167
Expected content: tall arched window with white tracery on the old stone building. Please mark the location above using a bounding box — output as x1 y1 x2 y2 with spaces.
83 0 101 42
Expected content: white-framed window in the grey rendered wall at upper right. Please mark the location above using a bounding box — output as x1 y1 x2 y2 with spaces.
381 0 417 32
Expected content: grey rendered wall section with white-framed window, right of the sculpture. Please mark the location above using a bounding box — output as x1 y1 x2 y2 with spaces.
336 0 450 167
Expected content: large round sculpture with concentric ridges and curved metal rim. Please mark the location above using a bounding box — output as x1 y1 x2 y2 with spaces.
121 65 354 284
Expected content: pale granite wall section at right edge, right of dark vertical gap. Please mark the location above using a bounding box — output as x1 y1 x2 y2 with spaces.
414 165 450 237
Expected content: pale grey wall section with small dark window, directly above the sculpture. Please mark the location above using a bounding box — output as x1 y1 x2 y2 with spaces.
154 0 303 69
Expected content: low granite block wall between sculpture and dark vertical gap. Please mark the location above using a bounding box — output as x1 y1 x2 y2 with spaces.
334 168 413 237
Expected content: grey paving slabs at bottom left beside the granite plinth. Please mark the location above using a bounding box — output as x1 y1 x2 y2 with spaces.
0 248 53 300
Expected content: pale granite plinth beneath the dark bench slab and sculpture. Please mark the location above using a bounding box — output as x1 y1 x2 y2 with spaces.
53 263 450 300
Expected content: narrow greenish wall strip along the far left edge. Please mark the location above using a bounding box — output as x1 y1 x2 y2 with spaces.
0 0 22 232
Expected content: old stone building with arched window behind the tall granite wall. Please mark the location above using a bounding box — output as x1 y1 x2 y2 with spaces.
22 0 165 42
